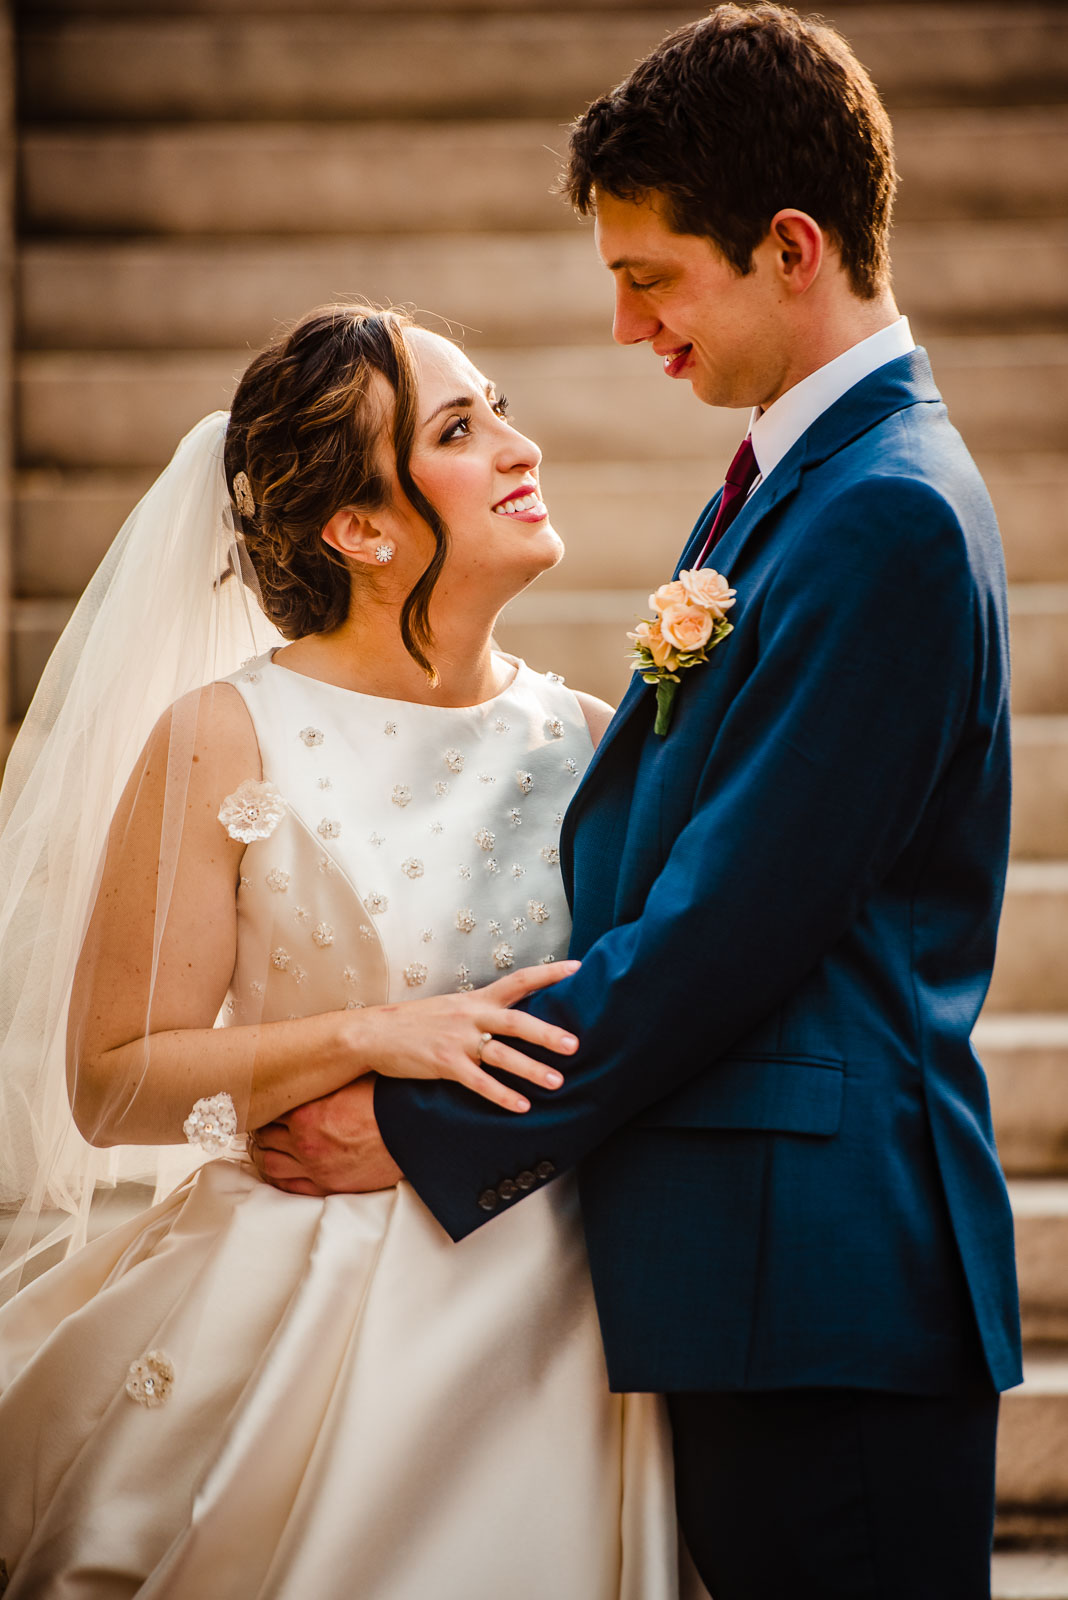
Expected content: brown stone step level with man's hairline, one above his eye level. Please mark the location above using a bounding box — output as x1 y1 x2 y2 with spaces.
19 106 1068 235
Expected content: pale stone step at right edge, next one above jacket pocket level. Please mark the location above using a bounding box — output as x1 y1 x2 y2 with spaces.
986 861 1068 1013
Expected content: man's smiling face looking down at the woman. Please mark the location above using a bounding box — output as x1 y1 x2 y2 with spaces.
595 190 785 406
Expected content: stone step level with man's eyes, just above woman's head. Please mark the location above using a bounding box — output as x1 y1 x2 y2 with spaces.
16 216 1068 350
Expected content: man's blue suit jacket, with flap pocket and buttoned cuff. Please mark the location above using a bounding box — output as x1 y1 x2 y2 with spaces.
376 350 1020 1394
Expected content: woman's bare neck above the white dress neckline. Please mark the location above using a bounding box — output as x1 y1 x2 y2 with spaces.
278 606 512 706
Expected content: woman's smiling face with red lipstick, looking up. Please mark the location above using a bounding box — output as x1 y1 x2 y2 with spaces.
396 328 563 600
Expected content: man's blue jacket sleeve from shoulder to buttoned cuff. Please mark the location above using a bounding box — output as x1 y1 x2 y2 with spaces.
374 480 998 1238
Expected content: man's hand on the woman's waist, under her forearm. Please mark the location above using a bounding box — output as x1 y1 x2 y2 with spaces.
248 1077 403 1198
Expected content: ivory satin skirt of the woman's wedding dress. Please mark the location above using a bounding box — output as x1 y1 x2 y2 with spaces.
0 1162 679 1600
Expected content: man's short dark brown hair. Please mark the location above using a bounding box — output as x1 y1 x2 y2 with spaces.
563 5 897 299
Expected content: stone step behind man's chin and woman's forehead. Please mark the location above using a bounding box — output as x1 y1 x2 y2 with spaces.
18 334 1068 467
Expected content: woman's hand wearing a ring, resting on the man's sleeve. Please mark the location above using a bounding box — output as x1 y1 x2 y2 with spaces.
355 962 580 1112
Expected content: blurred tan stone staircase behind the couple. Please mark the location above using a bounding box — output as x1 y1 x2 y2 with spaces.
10 0 1068 1600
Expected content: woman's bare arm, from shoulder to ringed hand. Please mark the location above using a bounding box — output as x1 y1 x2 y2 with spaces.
67 685 576 1146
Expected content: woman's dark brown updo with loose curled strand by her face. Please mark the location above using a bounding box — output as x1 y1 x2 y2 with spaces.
224 304 448 680
